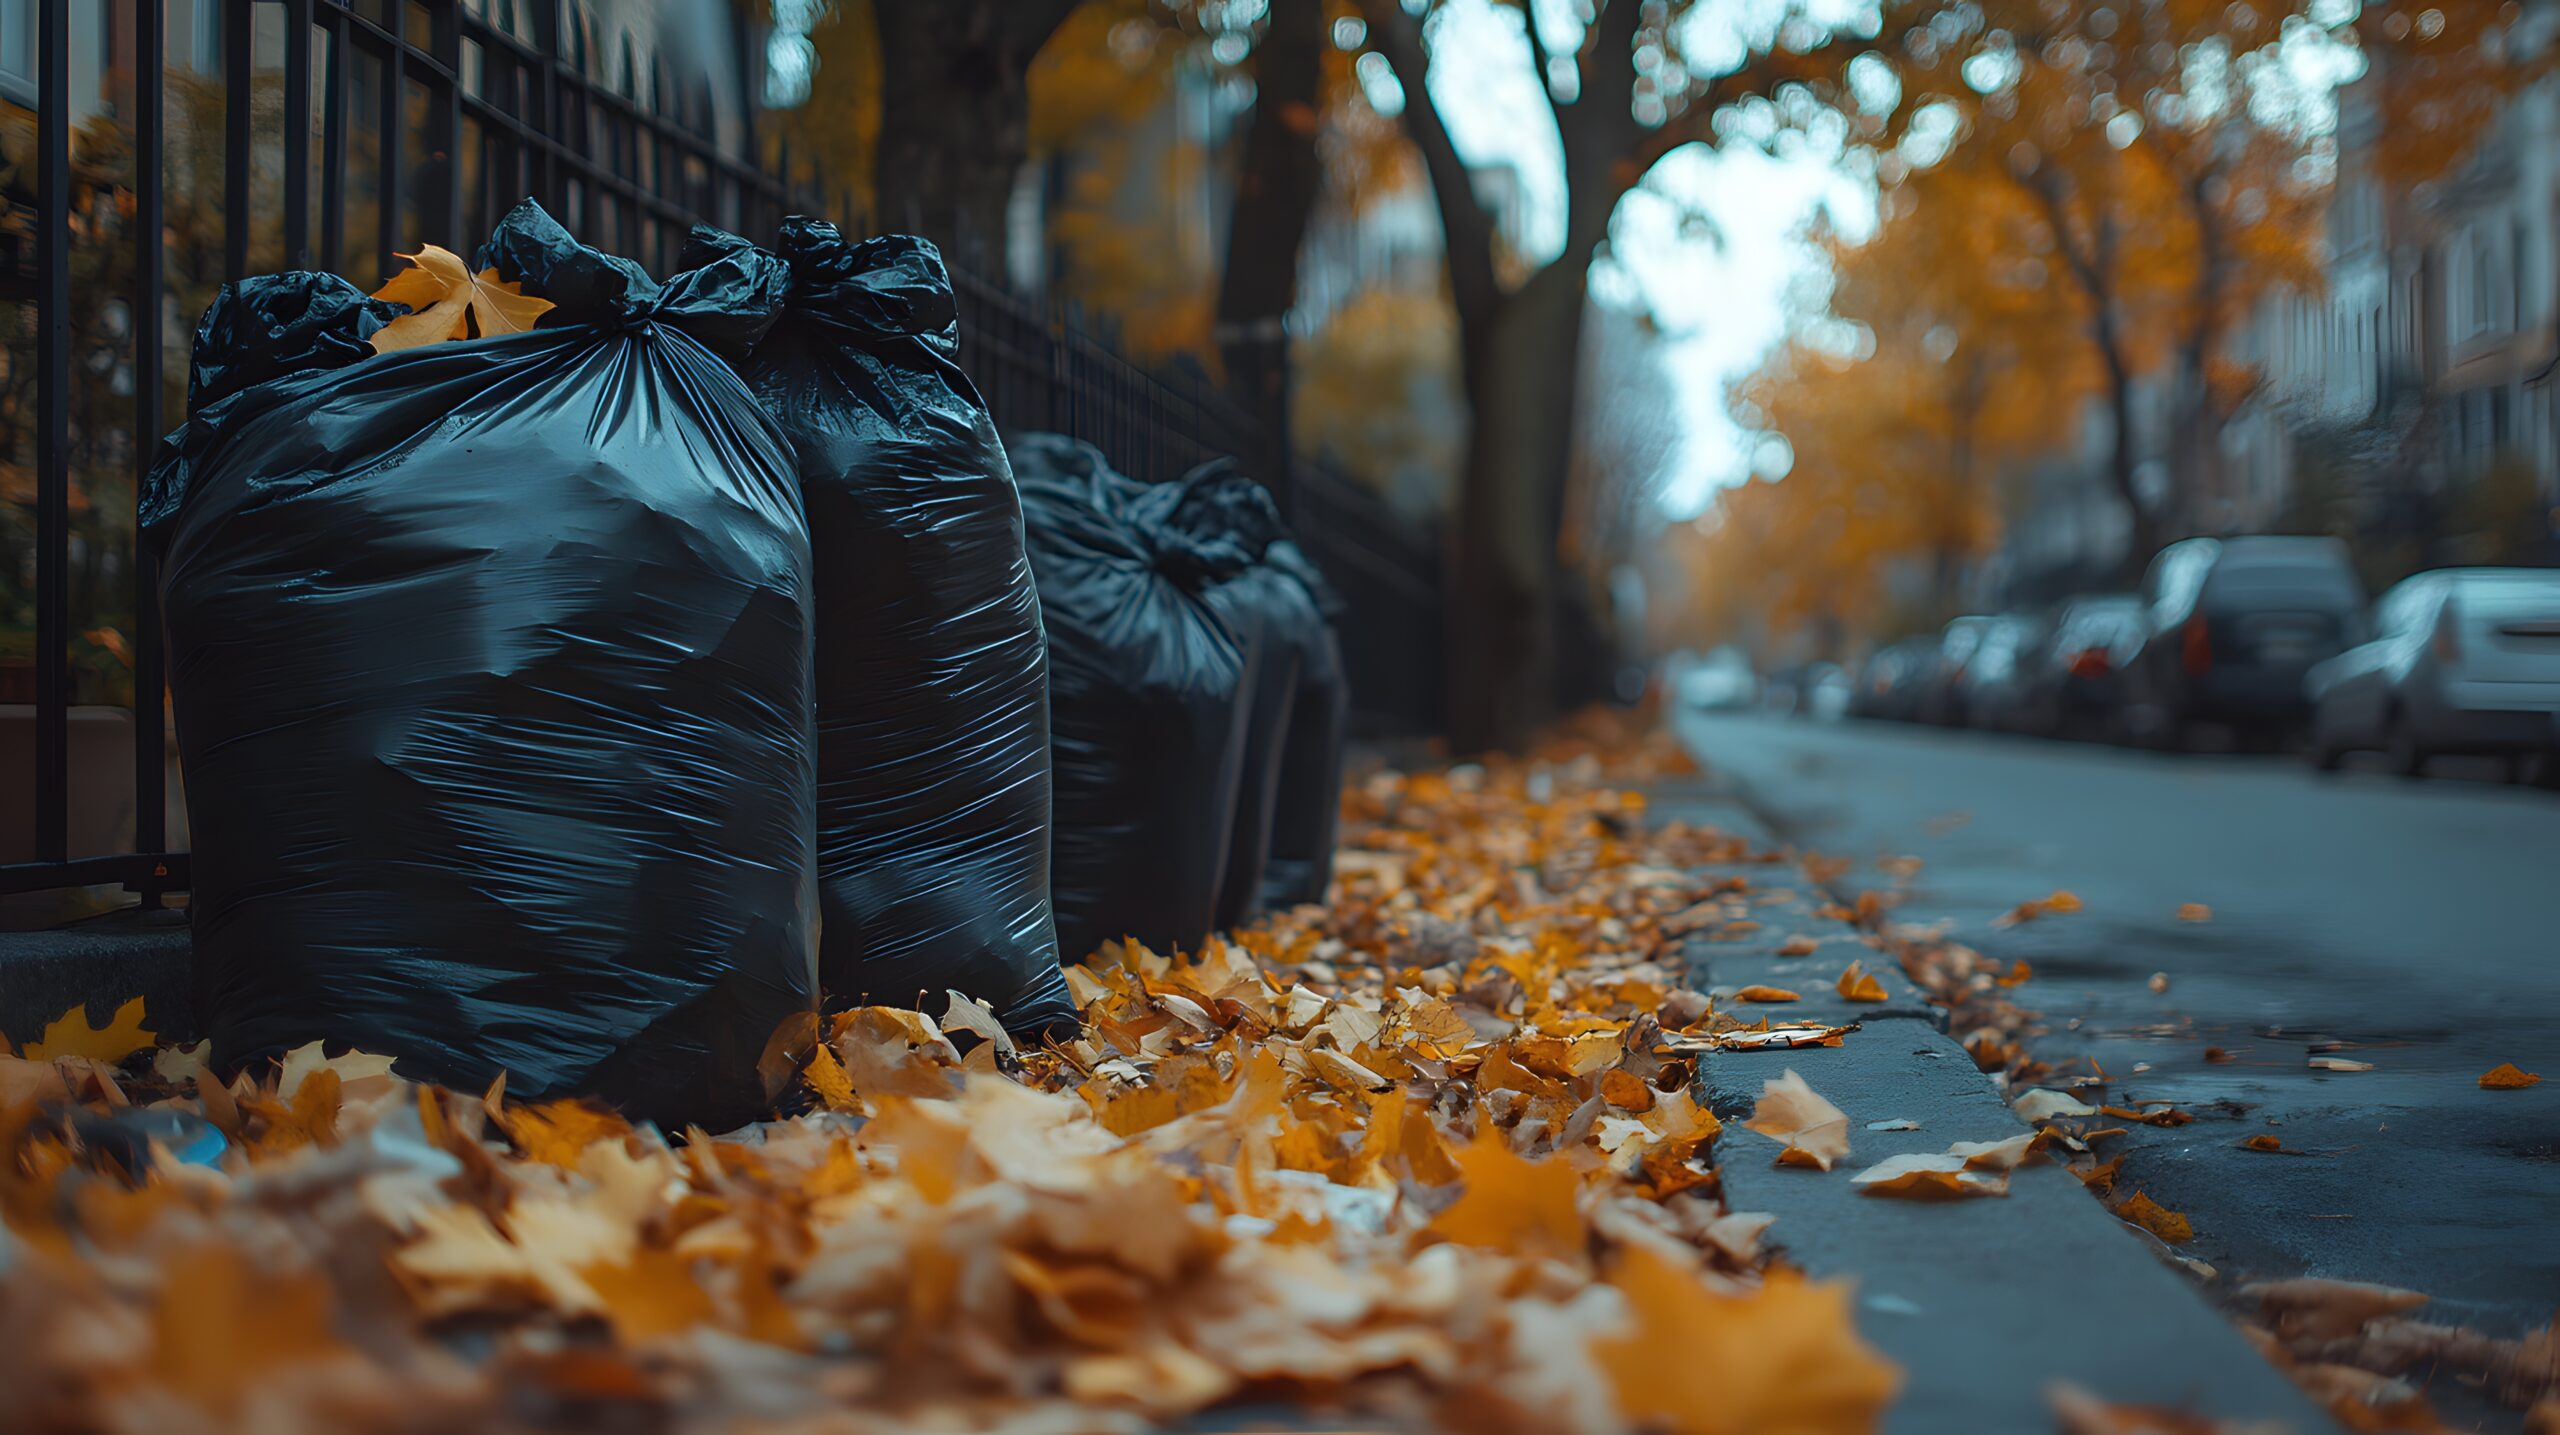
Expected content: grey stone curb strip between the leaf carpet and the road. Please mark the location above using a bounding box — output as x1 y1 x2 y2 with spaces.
1649 778 2335 1435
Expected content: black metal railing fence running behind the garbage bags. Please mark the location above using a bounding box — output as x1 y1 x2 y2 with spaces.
0 0 1439 906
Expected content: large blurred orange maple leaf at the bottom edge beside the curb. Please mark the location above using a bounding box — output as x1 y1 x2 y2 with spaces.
1590 1246 1902 1435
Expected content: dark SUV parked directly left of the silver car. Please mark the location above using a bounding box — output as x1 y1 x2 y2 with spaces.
2125 537 2365 747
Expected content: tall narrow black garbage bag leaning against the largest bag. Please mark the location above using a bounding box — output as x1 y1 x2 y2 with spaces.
689 217 1075 1041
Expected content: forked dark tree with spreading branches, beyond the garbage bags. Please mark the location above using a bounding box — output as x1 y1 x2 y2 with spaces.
1362 0 1892 752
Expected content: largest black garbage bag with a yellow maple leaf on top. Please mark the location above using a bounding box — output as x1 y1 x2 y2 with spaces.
143 205 817 1128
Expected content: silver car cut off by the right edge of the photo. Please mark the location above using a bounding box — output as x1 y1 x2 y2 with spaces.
2304 568 2560 778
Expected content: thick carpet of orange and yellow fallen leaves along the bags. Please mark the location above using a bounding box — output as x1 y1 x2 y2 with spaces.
0 726 1897 1432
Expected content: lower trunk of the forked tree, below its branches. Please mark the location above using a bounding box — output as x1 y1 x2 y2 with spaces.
1441 261 1587 752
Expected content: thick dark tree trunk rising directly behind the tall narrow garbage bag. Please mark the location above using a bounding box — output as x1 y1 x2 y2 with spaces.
873 0 1073 276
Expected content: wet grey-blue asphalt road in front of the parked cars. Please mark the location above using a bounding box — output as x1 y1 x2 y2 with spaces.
1682 714 2560 1338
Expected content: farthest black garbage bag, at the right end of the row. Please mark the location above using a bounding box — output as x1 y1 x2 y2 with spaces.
1149 458 1352 905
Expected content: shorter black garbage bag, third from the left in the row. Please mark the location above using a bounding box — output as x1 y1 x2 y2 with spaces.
1006 435 1252 962
